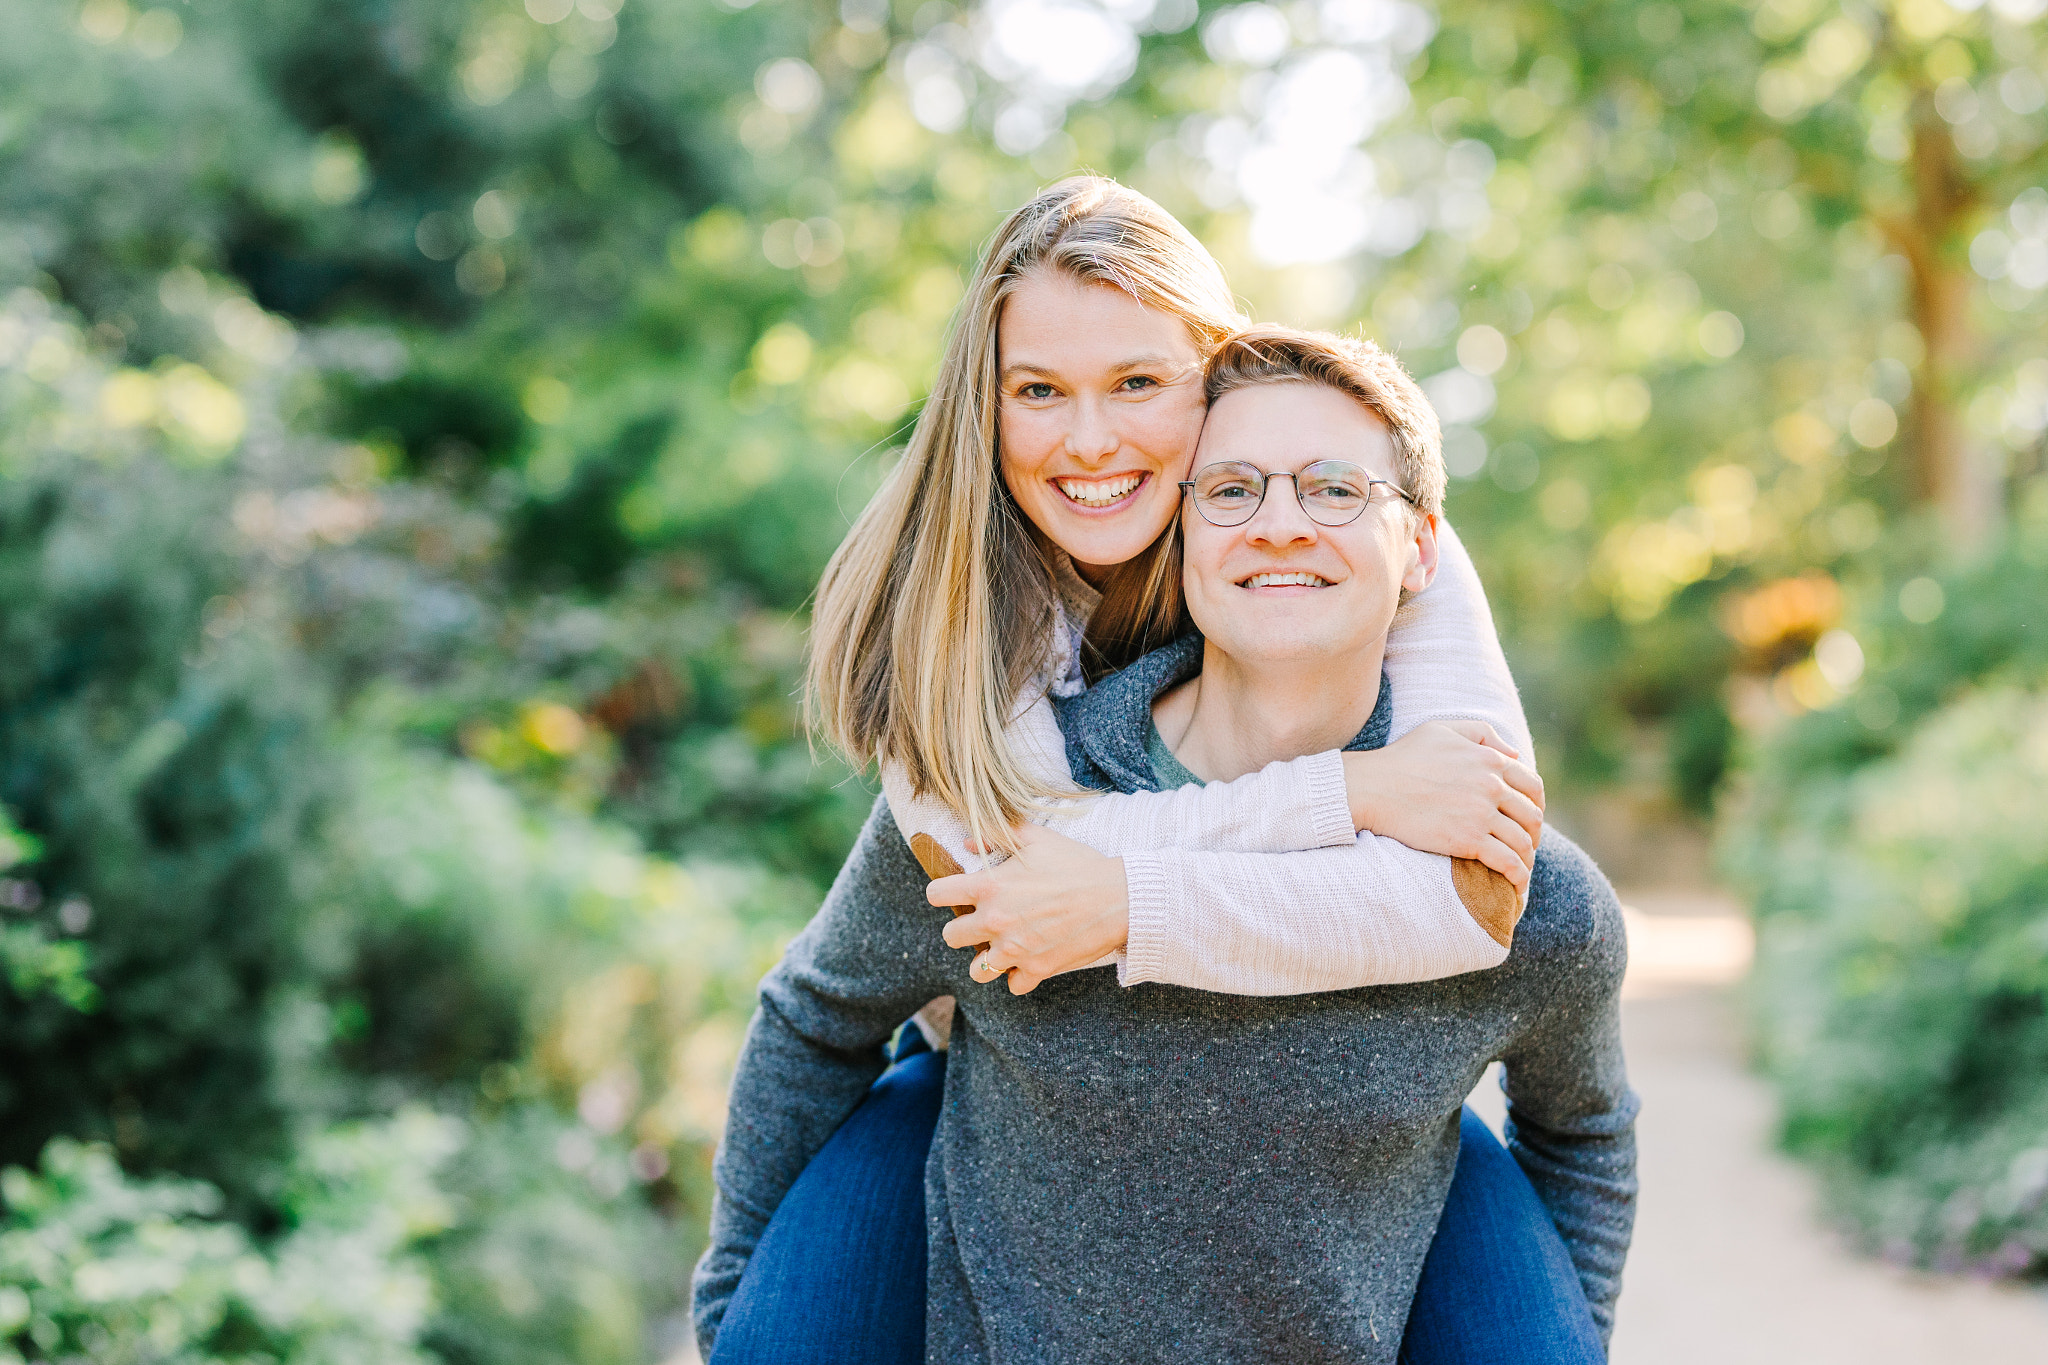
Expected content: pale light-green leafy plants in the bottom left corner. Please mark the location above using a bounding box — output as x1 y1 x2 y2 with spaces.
0 1111 459 1365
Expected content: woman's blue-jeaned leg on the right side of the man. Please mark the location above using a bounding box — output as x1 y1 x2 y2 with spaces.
1401 1109 1608 1365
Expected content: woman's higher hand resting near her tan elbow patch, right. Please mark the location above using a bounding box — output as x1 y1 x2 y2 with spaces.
1343 720 1542 894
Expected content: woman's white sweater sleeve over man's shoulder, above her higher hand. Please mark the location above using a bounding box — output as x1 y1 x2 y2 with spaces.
1384 520 1536 767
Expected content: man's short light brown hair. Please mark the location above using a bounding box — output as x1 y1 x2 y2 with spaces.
1204 327 1444 512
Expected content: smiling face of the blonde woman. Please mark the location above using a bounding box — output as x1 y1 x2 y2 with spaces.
995 270 1202 577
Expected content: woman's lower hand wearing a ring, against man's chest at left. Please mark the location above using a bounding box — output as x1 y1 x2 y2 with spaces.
924 825 1130 995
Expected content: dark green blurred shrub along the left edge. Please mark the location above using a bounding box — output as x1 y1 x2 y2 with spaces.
0 463 328 1191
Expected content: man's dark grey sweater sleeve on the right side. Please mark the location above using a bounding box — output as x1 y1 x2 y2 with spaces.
1501 831 1638 1342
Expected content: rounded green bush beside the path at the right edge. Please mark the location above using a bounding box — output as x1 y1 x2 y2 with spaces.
1726 507 2048 1275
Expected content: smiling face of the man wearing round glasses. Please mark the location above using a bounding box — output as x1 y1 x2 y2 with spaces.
1182 383 1436 665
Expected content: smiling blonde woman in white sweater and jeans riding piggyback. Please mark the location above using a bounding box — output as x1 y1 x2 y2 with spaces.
698 178 1583 1365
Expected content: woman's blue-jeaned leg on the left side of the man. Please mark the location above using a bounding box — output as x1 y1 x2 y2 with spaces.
711 1029 946 1365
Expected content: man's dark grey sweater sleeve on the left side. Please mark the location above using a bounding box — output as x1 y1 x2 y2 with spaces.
690 802 967 1361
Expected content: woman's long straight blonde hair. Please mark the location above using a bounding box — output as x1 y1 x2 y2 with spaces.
805 176 1243 847
